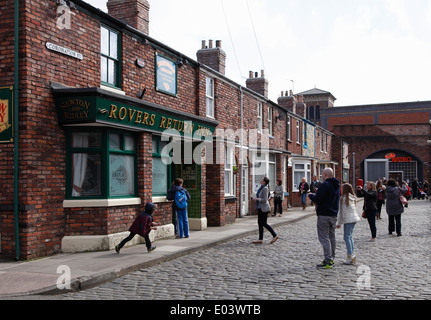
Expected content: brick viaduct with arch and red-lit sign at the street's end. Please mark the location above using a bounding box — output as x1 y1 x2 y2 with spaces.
301 89 431 188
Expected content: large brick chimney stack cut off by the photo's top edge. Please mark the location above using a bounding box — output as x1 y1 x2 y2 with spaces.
106 0 150 35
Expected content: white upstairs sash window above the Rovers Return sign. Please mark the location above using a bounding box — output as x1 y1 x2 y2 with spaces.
100 26 121 88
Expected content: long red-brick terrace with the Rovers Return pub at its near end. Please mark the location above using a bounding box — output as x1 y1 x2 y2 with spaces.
0 0 344 259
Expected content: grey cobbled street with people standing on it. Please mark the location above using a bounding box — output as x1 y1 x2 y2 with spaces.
58 200 431 300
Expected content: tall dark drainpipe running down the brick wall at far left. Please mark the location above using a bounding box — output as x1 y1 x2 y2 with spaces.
13 0 20 261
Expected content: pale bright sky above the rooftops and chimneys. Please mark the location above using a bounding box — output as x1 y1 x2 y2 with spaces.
84 0 431 107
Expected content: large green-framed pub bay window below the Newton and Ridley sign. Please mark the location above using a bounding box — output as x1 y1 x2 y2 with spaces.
67 131 136 199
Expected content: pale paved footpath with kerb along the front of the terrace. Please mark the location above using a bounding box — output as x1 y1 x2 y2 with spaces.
0 207 315 300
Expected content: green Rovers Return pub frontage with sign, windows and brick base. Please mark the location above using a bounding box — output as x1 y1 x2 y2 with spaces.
52 87 218 252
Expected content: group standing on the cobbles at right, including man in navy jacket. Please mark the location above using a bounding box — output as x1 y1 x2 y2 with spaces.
308 168 408 269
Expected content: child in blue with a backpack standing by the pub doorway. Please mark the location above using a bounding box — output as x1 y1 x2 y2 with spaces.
166 178 191 239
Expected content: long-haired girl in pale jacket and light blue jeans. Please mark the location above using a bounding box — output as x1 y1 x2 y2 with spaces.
337 183 361 265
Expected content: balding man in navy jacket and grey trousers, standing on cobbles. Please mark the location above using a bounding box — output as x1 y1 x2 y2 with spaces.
308 168 340 269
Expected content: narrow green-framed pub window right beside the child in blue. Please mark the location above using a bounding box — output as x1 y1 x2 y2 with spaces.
153 136 170 197
